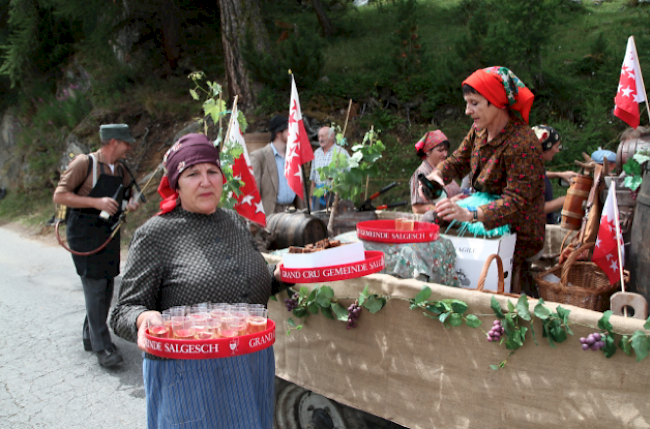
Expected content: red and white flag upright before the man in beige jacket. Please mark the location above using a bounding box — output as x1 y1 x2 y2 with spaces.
284 75 314 200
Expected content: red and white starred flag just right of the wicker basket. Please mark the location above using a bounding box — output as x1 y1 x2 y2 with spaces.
591 181 625 285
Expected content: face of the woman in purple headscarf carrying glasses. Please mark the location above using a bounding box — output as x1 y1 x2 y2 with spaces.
178 162 223 214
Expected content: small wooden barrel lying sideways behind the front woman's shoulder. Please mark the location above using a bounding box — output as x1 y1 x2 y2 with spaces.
266 213 327 249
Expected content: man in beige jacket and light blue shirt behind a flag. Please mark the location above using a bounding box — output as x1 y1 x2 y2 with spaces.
251 115 305 215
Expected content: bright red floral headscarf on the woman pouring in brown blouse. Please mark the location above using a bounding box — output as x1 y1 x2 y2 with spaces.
463 66 535 123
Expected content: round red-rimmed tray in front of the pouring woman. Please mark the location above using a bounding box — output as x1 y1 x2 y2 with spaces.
357 219 440 243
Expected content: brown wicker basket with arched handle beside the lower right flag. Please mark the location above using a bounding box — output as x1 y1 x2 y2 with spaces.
535 243 630 312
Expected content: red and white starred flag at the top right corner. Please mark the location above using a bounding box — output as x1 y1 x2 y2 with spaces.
614 36 645 128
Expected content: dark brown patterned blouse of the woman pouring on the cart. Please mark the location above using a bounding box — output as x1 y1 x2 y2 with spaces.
438 117 546 264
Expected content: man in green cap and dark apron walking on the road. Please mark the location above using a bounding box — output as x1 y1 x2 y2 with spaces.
53 124 138 367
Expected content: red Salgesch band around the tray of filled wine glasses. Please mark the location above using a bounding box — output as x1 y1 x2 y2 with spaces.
146 319 275 359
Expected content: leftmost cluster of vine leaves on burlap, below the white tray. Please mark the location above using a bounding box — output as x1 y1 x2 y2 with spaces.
285 285 387 335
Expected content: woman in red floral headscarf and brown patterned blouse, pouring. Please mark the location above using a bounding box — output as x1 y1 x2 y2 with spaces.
427 67 546 294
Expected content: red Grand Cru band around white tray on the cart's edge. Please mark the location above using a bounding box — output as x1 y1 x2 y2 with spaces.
280 250 385 283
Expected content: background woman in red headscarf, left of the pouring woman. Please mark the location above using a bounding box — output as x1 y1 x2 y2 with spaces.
409 130 460 214
